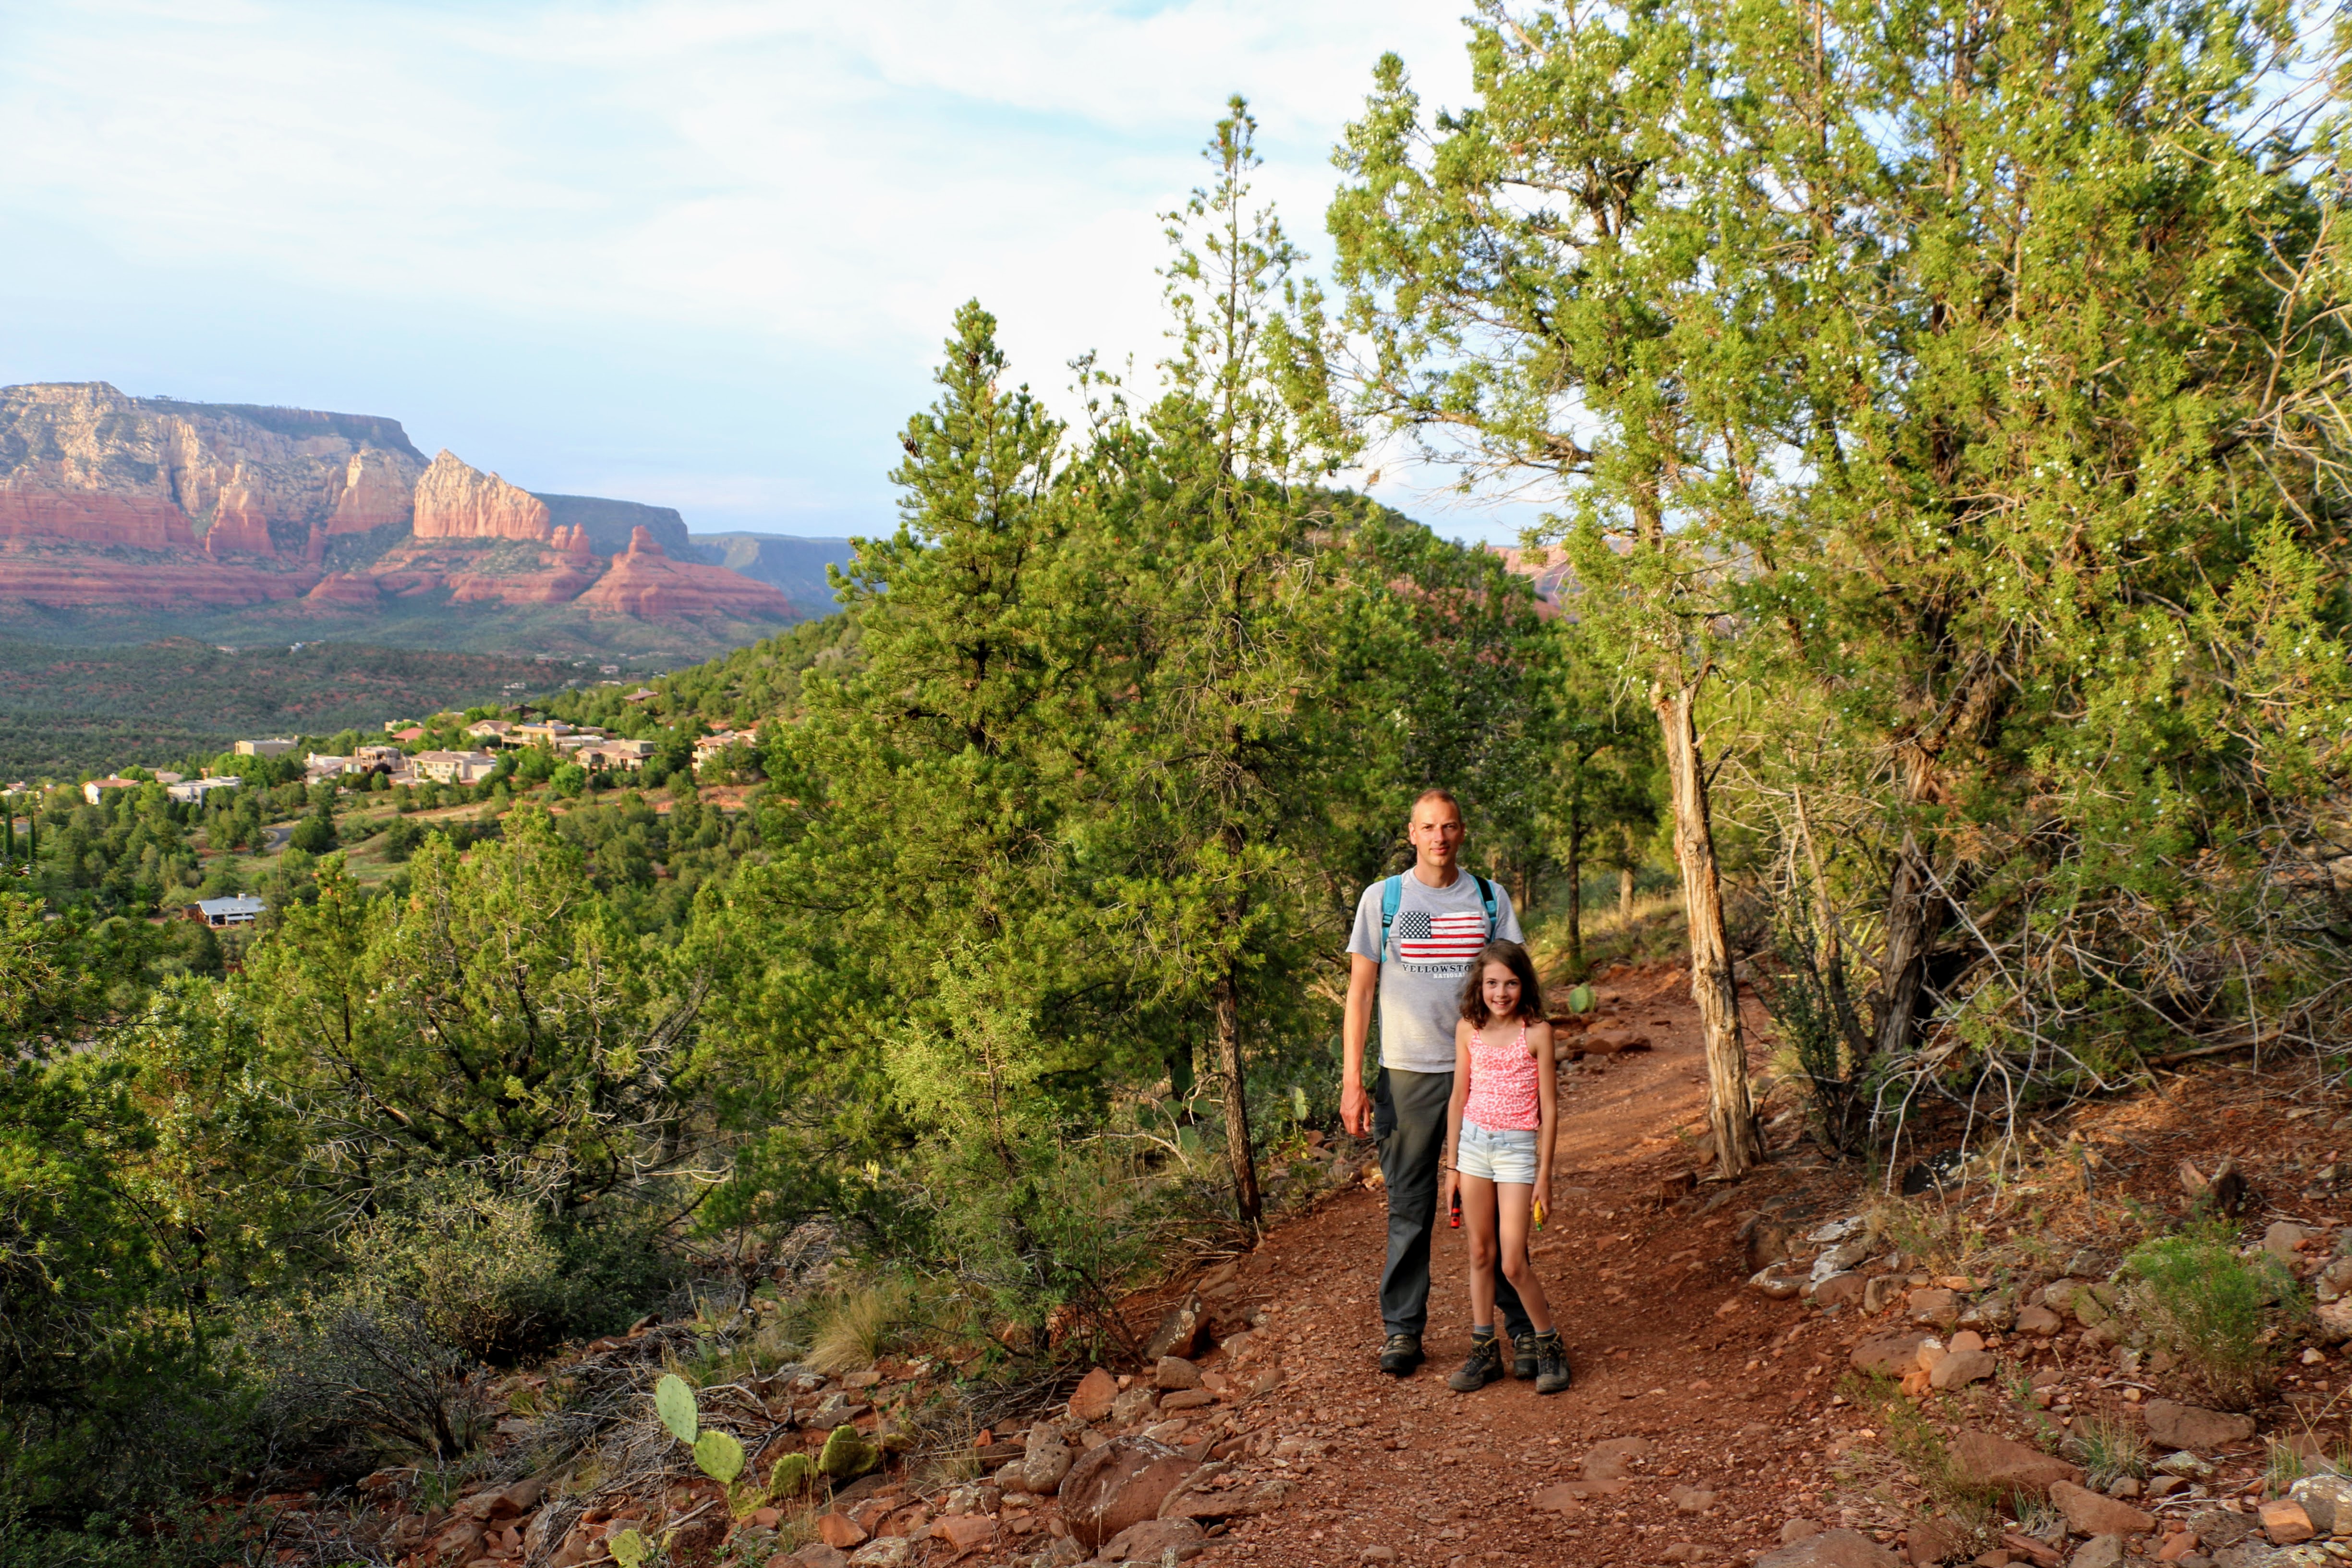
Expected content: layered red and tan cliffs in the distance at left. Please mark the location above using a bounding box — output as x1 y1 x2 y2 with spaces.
0 381 795 635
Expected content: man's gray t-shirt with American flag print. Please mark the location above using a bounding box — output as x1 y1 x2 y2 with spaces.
1348 872 1527 1072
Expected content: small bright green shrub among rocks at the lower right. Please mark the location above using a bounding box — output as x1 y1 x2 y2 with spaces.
2122 1222 2303 1408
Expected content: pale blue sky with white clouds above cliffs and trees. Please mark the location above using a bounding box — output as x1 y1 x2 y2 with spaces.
0 0 1529 538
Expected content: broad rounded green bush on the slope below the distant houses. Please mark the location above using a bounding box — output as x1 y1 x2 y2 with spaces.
238 809 705 1220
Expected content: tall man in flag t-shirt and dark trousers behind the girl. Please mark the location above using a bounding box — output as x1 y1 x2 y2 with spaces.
1338 790 1536 1378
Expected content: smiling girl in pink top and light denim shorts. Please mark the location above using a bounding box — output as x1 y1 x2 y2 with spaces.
1437 943 1569 1394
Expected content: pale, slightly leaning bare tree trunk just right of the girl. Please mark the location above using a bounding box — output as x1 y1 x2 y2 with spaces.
1651 682 1764 1178
